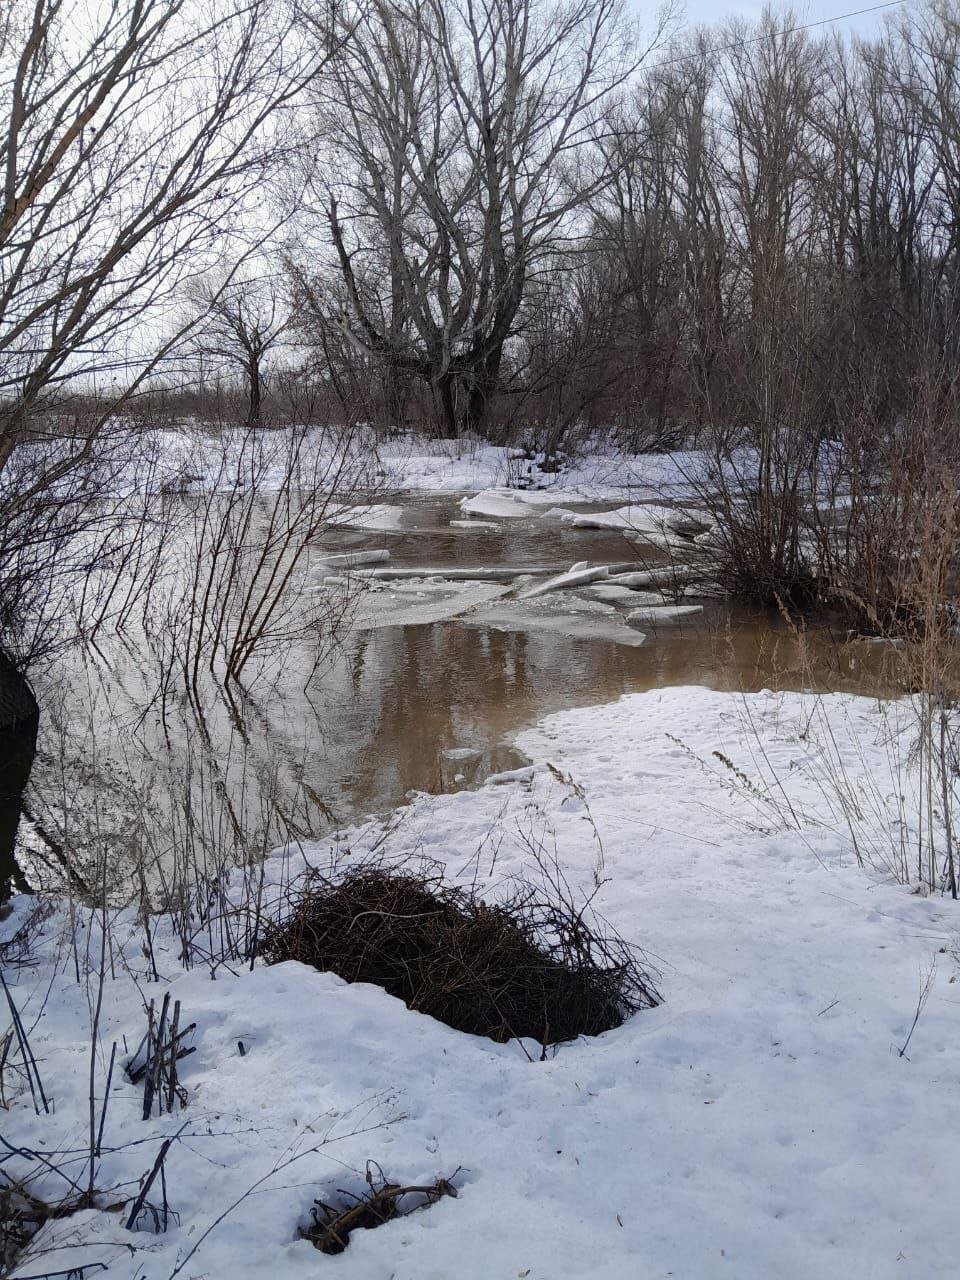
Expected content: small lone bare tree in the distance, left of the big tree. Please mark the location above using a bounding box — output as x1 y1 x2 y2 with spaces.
188 276 291 426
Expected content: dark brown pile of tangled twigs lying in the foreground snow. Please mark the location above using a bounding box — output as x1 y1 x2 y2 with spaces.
260 863 659 1046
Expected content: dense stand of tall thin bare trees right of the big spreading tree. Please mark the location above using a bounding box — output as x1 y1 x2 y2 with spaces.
496 4 960 460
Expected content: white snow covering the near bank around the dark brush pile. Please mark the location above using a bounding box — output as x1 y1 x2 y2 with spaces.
1 689 960 1280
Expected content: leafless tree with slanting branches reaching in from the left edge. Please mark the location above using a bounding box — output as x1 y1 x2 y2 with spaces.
0 0 324 660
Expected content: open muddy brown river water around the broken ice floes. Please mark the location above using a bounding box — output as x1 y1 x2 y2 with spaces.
16 495 911 885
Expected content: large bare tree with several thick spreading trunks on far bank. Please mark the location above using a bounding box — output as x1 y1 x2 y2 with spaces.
295 0 660 435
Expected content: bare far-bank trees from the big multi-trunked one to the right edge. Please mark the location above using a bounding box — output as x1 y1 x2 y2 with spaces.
291 0 960 617
